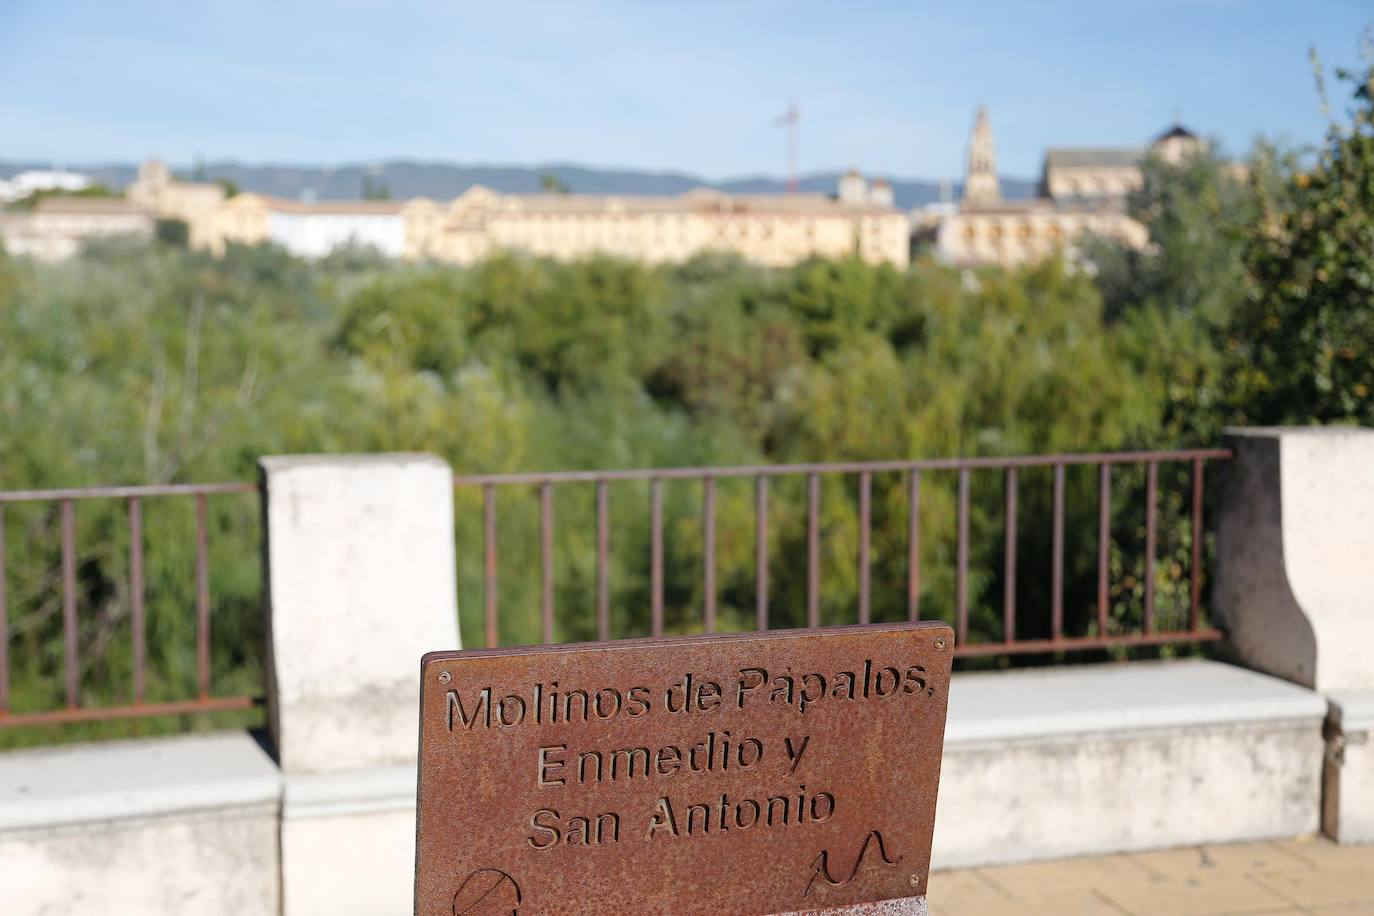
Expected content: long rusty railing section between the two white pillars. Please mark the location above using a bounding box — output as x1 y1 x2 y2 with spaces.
455 449 1231 656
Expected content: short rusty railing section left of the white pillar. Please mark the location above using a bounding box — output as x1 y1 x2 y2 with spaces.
0 483 258 729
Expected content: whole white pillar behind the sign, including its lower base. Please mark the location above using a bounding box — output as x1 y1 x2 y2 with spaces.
260 455 459 916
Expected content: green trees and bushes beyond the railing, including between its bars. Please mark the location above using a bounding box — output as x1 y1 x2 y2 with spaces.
0 53 1374 747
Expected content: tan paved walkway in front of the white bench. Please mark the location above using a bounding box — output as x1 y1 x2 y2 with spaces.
927 839 1374 916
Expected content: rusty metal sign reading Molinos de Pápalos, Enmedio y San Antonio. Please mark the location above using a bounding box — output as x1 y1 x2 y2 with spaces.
415 623 954 916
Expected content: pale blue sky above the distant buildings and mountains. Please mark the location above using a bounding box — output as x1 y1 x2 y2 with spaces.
0 0 1374 179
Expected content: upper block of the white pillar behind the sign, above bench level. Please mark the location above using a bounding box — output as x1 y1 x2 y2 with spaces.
261 455 459 773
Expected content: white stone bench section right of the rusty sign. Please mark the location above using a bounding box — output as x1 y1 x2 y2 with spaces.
933 661 1326 868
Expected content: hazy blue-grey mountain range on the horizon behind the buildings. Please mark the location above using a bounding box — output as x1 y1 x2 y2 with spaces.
0 159 1037 209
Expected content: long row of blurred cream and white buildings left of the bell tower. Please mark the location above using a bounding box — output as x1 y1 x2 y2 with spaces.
128 161 911 266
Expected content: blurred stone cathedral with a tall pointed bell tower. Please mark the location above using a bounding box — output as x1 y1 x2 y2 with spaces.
921 107 1205 266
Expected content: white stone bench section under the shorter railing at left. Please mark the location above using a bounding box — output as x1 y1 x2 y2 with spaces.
0 733 280 916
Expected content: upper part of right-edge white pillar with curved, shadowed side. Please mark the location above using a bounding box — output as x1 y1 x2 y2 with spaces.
1213 427 1374 692
